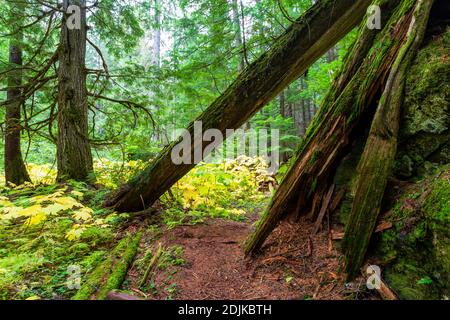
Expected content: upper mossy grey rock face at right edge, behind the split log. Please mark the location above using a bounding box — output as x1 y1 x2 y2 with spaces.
395 30 450 177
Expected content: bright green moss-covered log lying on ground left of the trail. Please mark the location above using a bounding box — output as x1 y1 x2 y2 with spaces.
72 233 142 300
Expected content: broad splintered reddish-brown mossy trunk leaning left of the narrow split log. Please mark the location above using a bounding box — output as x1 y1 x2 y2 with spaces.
245 0 416 254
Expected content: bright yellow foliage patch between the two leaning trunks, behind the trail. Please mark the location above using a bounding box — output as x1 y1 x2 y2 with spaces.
162 157 276 227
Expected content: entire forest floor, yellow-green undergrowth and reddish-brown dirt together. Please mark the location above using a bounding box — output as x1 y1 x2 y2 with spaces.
0 158 376 300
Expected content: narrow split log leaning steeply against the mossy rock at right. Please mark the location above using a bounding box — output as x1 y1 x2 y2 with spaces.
342 0 433 280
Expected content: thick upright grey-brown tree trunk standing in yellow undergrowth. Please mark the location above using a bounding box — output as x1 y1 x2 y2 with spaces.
57 0 93 181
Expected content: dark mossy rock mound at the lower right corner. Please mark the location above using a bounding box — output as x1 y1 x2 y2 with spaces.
377 166 450 299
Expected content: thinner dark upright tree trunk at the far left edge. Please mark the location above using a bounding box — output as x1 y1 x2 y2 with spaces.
5 5 31 185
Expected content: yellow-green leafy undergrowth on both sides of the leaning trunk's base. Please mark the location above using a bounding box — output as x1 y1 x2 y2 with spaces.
0 157 276 299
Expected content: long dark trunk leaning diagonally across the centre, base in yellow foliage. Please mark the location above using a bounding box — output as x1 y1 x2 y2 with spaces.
106 0 371 211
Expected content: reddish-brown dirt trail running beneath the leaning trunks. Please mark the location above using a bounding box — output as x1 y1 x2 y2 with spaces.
125 217 345 300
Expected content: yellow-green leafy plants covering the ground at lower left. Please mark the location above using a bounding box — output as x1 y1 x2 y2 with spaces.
0 171 126 299
